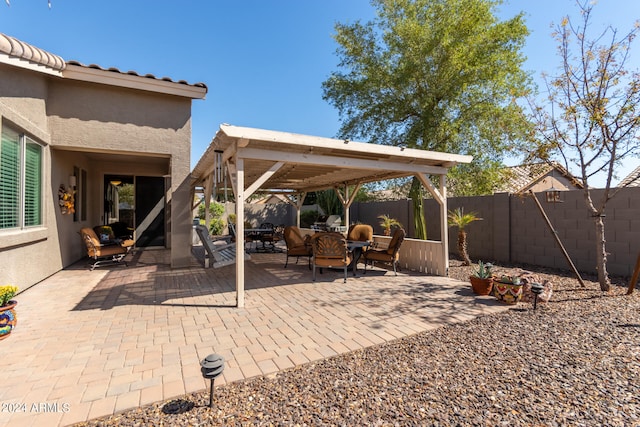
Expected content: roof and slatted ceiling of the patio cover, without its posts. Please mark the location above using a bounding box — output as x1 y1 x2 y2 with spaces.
191 124 472 198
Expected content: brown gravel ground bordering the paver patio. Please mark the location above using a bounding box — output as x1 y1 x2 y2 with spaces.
72 261 640 426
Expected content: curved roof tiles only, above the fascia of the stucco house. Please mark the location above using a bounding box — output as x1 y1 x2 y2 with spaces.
0 33 207 89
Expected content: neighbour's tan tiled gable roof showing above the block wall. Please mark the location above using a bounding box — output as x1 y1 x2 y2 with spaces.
496 162 584 194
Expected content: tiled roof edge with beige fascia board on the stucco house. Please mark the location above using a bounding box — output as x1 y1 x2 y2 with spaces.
0 33 207 99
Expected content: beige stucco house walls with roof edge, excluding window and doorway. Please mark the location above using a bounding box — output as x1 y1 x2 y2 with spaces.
0 34 206 289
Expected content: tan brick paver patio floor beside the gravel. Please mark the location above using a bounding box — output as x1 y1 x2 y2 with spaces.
0 250 506 426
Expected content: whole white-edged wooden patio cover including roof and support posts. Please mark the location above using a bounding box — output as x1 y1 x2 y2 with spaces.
191 124 472 307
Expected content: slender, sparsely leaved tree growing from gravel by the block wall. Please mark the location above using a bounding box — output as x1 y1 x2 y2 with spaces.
529 1 640 291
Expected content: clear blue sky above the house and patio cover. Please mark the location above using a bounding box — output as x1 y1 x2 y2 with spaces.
0 0 640 186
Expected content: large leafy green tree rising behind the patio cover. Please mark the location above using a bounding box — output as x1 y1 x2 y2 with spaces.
323 0 530 238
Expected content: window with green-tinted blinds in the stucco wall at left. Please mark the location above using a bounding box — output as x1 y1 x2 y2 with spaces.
0 126 42 229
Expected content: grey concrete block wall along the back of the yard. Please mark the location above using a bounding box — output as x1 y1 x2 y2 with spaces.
350 187 640 276
